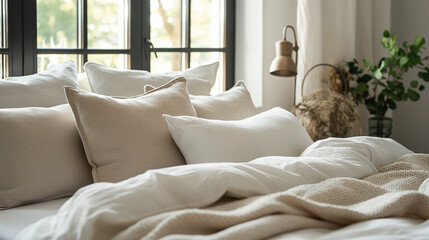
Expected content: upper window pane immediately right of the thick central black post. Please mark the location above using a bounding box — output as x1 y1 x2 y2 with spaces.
150 0 182 48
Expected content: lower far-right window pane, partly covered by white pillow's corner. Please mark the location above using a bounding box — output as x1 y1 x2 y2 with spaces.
191 52 225 95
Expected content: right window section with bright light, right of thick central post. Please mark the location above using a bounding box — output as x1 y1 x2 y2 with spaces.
150 0 226 92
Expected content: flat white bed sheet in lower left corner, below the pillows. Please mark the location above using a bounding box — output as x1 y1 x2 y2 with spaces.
0 198 69 240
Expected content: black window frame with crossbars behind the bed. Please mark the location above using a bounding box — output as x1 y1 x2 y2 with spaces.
0 0 235 90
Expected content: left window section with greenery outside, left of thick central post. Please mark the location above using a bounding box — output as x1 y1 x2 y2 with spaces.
36 0 130 72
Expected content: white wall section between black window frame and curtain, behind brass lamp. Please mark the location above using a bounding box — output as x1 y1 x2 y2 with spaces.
235 0 299 110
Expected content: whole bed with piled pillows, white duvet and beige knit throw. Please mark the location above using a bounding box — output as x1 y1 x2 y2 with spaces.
0 62 429 239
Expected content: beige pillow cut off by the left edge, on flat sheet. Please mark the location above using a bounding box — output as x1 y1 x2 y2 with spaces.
0 104 92 209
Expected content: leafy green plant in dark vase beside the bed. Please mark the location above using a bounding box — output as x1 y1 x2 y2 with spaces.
347 30 429 137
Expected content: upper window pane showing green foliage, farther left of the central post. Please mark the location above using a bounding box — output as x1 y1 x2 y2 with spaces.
37 0 77 48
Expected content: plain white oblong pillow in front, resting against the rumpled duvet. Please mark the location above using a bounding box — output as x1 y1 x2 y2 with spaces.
163 107 313 164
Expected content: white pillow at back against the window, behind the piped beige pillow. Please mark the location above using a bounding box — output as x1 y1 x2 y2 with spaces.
84 62 219 97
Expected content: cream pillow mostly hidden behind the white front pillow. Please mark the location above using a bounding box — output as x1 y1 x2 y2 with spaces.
145 81 258 120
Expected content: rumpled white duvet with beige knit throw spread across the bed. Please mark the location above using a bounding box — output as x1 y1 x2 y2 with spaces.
5 138 429 239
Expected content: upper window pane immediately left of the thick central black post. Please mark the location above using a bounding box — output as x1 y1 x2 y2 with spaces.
88 0 129 49
